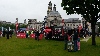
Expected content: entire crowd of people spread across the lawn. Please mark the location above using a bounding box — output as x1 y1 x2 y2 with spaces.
0 26 94 51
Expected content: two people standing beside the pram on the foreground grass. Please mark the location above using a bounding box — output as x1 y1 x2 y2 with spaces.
64 29 79 51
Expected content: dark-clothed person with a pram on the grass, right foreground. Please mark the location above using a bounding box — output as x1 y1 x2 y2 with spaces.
67 29 78 51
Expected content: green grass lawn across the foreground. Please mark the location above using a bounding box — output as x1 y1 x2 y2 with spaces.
0 37 100 56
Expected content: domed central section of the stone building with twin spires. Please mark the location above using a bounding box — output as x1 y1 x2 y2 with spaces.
44 1 62 27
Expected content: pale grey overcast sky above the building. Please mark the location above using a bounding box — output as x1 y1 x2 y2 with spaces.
0 0 81 23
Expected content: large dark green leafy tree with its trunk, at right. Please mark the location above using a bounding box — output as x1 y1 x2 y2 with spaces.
61 0 100 45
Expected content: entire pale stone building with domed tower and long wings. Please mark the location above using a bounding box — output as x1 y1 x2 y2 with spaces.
28 1 98 32
